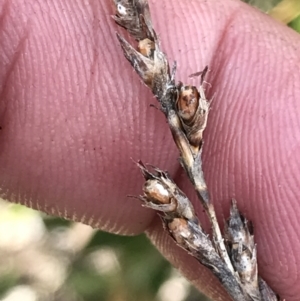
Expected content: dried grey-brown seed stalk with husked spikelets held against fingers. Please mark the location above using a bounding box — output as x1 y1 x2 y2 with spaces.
113 0 279 301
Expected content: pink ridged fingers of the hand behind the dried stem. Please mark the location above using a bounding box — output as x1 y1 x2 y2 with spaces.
0 0 300 301
